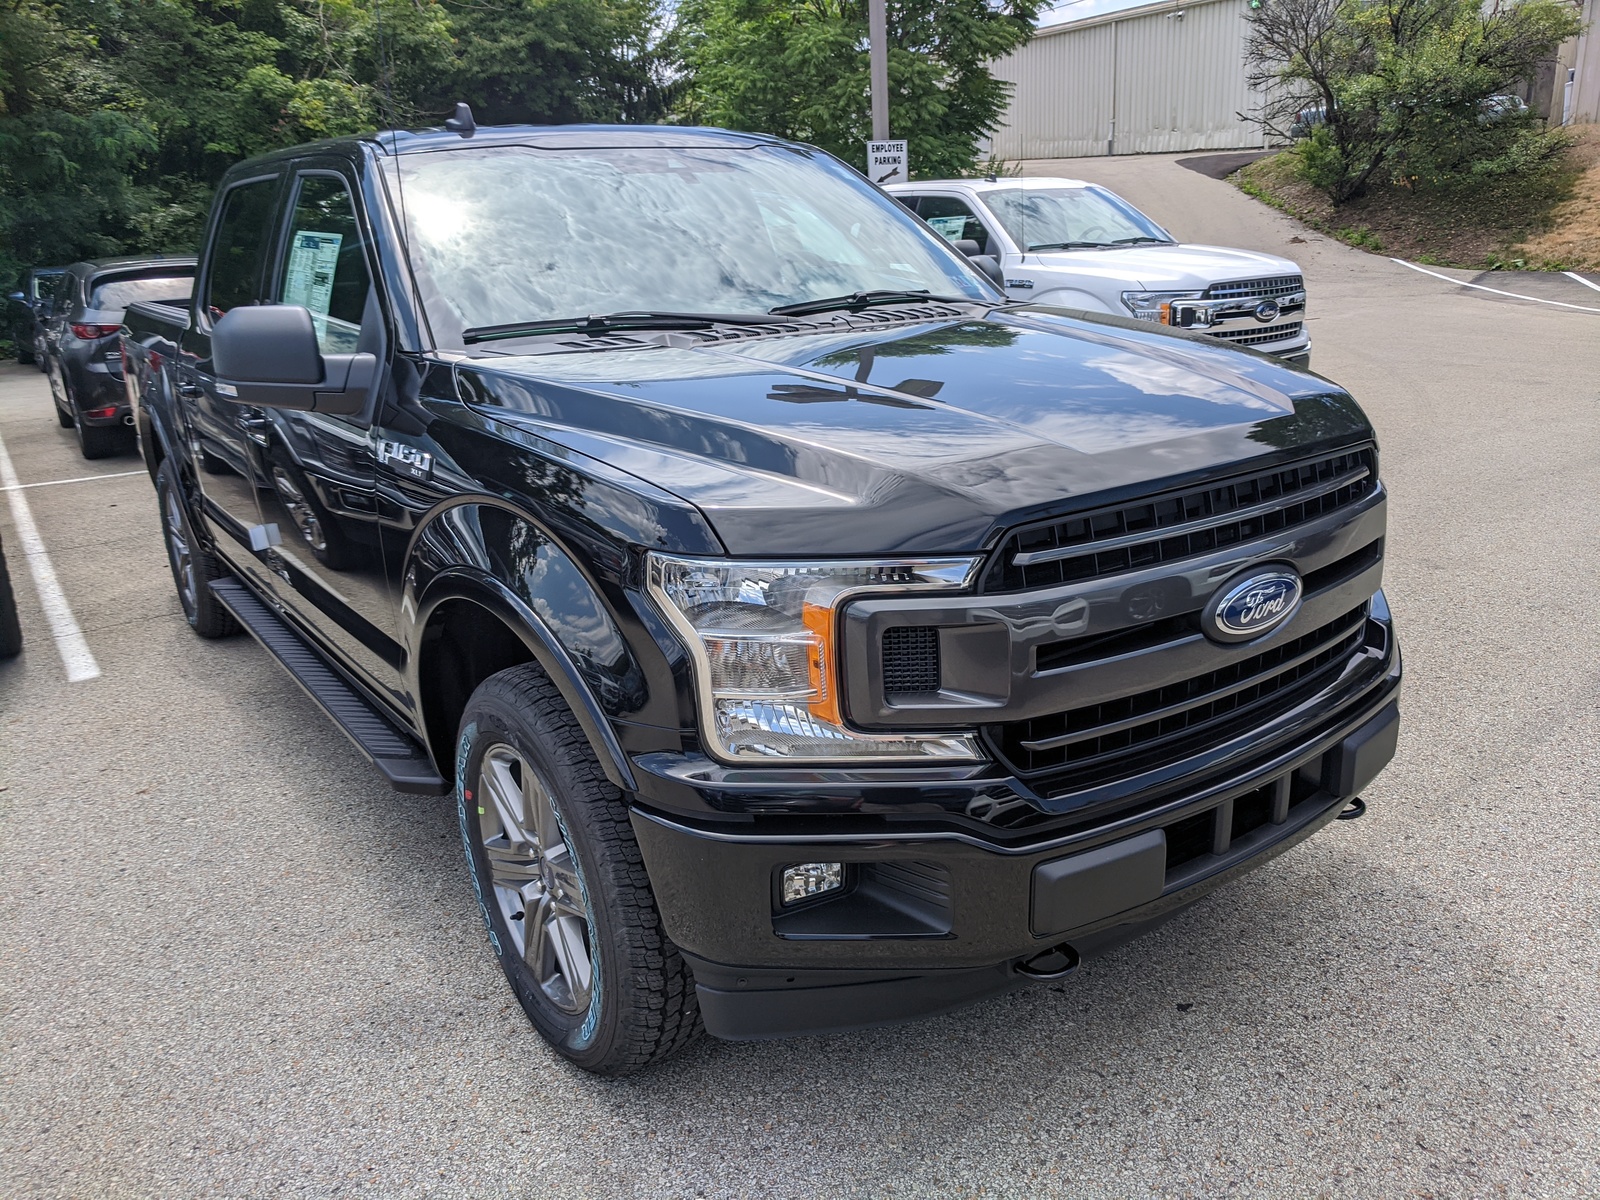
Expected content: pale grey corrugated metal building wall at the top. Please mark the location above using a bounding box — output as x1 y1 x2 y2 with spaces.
992 0 1261 158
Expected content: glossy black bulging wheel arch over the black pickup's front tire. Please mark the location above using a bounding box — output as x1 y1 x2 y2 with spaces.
402 501 650 790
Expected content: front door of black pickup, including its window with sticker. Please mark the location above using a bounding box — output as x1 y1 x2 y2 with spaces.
243 160 402 698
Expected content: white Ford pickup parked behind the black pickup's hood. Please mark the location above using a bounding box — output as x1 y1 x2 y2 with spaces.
886 179 1310 363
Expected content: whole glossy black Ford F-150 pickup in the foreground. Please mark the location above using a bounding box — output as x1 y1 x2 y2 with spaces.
123 120 1400 1074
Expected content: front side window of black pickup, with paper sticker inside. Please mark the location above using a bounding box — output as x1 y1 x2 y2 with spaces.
278 174 371 354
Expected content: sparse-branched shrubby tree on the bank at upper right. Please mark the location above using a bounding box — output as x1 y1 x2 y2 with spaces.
1245 0 1579 203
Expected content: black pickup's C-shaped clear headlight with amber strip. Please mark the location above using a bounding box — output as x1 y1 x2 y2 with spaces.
650 554 982 762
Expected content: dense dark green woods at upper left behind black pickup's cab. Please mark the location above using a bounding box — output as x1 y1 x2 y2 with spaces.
0 0 670 305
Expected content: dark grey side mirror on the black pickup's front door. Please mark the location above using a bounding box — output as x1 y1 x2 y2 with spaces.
211 304 378 416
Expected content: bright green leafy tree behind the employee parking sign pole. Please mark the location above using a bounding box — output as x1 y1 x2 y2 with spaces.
678 0 1040 178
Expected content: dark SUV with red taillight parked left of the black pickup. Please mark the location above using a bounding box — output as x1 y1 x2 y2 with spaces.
45 254 195 458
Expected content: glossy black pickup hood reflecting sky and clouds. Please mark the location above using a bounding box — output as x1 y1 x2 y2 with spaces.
458 309 1371 557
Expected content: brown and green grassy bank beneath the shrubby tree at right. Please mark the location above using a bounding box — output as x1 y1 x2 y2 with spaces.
1230 125 1600 270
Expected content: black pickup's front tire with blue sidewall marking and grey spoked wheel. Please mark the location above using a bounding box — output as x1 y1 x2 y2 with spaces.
456 664 702 1075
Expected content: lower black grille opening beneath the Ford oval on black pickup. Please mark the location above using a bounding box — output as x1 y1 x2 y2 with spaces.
984 602 1366 794
